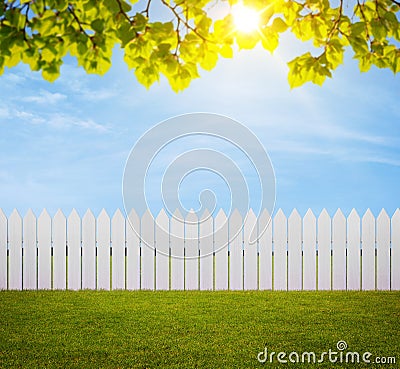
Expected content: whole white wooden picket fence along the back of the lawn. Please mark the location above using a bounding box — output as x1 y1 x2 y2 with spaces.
0 209 400 290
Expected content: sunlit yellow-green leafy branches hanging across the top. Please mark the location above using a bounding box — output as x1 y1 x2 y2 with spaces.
0 0 400 91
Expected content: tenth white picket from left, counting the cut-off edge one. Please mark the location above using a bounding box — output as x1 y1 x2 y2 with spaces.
126 209 140 290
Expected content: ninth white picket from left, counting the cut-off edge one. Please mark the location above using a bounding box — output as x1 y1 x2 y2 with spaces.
111 209 125 290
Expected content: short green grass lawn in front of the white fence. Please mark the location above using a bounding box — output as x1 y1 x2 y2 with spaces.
0 291 400 369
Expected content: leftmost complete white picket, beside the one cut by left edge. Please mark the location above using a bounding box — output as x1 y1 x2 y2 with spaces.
8 210 22 290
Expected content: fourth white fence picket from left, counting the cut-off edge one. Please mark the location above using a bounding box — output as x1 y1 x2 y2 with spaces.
37 209 51 290
